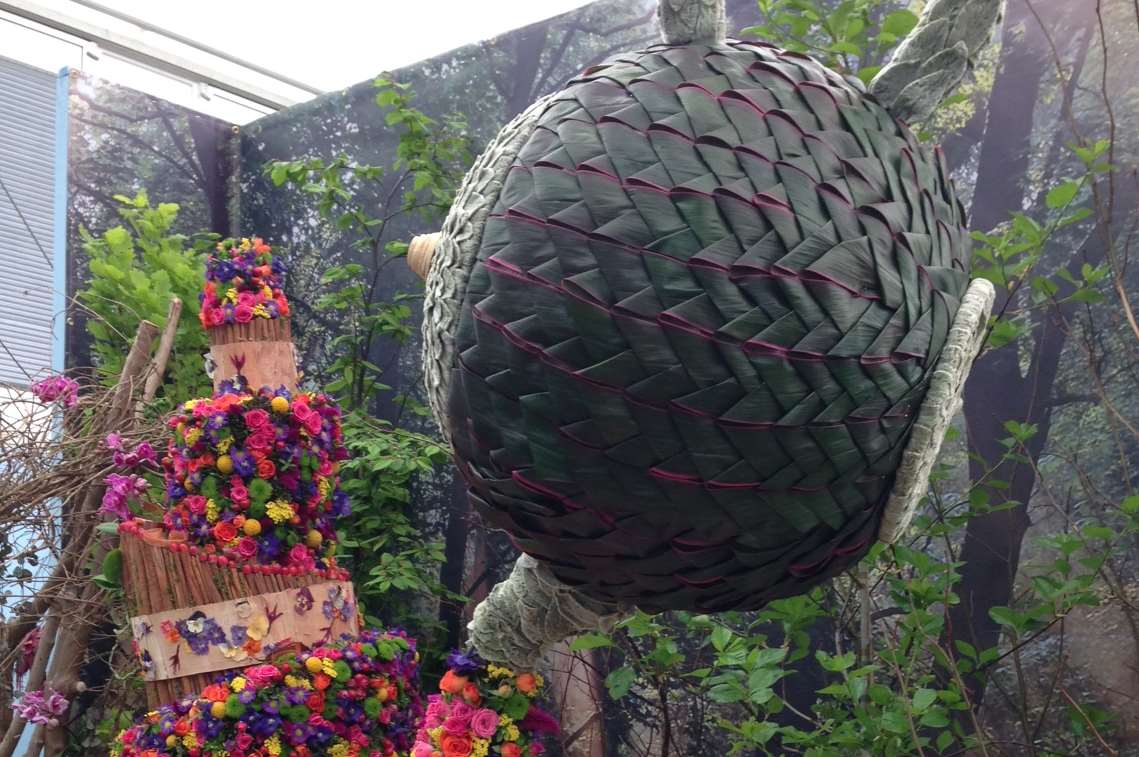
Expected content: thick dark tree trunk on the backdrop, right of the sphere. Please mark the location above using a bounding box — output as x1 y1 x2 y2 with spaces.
947 0 1104 707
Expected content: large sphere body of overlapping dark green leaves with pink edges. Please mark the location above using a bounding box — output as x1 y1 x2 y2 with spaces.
449 42 969 610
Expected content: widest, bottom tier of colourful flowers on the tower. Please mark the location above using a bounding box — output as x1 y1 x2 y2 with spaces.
112 631 423 757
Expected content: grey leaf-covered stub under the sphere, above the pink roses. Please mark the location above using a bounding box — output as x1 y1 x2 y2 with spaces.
467 554 633 669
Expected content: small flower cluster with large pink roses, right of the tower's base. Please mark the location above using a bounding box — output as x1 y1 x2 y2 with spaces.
411 652 558 757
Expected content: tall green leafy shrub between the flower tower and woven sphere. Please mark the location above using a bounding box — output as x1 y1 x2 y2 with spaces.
265 76 470 641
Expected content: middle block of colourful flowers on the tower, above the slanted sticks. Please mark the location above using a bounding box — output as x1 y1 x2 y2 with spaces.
163 388 350 570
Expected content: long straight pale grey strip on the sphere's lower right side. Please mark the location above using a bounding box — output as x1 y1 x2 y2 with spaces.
878 279 997 544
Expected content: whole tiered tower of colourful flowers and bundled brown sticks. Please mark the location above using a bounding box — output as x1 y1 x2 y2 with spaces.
114 239 423 757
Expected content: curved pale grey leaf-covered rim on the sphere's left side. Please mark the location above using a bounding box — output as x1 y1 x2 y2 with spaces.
423 96 552 443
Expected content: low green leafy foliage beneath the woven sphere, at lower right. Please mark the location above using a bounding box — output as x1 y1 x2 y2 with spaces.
573 478 1139 756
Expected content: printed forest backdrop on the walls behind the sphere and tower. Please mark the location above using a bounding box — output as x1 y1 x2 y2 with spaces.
55 0 1139 754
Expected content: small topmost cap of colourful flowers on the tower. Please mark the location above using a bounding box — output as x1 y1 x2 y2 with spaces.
198 237 289 329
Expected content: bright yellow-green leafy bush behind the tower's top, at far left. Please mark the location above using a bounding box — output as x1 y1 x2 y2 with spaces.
77 192 216 406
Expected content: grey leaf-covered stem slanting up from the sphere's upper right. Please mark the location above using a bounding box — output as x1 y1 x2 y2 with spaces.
870 0 1005 123
